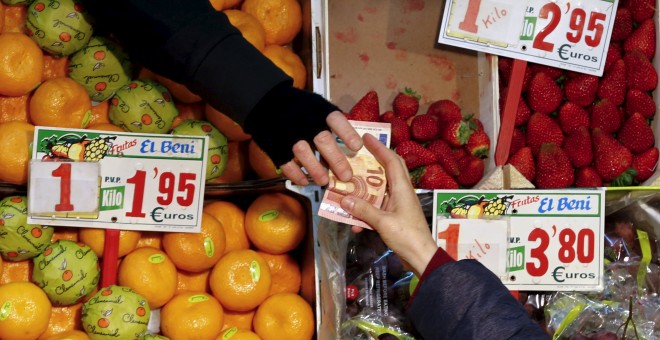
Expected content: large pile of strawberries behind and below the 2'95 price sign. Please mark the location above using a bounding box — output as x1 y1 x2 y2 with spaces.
499 0 658 188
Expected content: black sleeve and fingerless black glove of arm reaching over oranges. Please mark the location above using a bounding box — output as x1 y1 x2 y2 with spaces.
83 0 336 165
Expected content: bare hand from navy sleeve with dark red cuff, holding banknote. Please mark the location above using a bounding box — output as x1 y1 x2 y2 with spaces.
341 134 438 275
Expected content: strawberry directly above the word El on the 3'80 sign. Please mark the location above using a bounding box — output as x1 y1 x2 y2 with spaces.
536 143 575 189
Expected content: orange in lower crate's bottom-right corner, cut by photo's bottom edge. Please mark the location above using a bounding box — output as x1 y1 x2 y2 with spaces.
252 293 314 340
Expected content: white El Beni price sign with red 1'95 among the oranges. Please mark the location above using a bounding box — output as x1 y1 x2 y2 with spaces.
28 127 208 232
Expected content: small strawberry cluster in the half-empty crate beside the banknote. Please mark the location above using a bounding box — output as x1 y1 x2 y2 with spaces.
346 88 490 189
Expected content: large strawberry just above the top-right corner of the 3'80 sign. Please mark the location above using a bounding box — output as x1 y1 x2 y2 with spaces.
591 128 632 182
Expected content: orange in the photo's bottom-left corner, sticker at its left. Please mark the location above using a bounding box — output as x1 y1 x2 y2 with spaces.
0 282 51 340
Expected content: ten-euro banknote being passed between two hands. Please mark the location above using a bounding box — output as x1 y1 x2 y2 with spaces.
318 121 391 229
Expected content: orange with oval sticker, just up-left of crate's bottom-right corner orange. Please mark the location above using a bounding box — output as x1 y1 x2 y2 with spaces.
209 249 271 312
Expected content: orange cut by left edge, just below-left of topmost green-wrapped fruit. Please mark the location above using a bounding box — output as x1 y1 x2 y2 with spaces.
0 32 44 97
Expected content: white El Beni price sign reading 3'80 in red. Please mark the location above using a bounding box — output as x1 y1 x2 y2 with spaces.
433 189 605 291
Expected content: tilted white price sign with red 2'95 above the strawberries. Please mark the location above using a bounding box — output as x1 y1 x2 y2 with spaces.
438 0 618 76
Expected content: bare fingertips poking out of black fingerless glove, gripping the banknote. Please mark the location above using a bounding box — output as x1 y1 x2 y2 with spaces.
280 111 362 186
